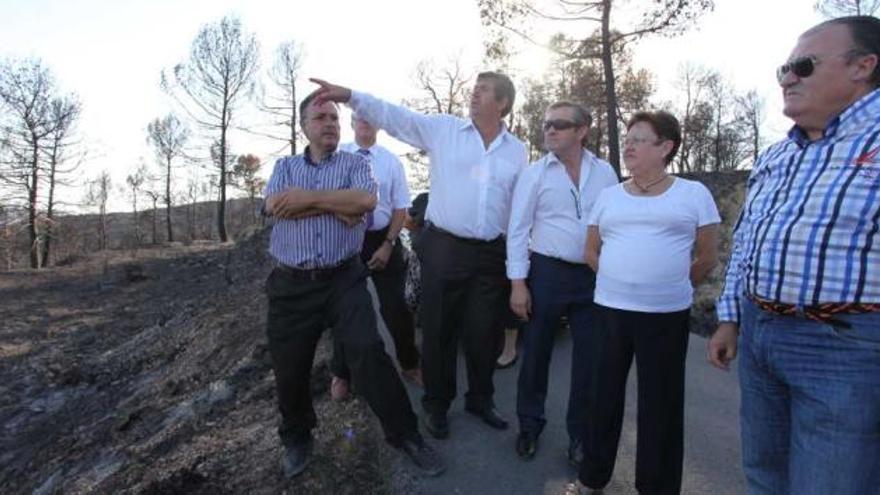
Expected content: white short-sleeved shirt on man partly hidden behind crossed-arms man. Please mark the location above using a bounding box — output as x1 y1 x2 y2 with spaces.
339 143 412 230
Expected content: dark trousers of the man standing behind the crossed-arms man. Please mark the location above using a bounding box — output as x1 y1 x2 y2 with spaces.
330 227 419 379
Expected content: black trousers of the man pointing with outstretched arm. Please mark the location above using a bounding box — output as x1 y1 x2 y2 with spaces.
415 226 510 413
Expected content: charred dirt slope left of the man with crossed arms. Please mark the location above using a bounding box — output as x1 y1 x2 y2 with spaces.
0 231 405 494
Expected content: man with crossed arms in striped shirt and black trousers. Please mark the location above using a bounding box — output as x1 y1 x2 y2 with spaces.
266 93 444 477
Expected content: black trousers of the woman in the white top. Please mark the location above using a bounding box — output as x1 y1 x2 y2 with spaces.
579 304 690 494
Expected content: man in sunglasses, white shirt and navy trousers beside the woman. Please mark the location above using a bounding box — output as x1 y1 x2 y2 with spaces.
507 101 618 465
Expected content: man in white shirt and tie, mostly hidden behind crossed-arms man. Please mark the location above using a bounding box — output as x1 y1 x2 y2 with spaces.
330 114 422 399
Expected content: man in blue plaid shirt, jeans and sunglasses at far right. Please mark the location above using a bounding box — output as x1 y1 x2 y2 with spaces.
708 16 880 495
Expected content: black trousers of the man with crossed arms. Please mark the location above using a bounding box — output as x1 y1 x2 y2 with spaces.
266 258 419 445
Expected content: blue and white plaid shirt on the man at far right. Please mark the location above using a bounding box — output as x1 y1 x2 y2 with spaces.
718 90 880 322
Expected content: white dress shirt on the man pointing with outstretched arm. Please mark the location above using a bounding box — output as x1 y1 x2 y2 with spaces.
349 91 527 240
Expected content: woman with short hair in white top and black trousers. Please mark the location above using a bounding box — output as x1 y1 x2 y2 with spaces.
579 111 721 494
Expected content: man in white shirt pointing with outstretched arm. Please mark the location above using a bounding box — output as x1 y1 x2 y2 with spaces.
312 72 527 438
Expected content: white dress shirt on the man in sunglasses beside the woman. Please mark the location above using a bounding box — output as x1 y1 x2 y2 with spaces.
507 150 618 280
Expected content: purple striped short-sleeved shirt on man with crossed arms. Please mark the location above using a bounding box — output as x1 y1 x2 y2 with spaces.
264 148 377 269
